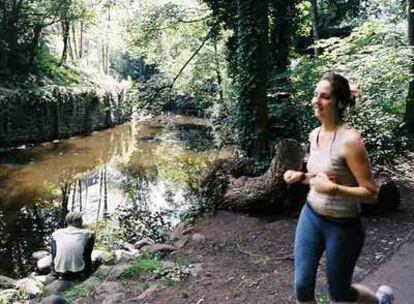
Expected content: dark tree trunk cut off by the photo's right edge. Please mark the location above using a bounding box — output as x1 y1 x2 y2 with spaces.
405 0 414 135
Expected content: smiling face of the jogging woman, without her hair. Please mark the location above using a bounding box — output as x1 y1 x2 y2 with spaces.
312 80 338 121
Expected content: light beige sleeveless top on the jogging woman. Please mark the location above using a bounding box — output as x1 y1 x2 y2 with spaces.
307 125 360 218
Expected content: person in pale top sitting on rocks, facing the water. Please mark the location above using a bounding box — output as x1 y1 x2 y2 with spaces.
51 211 95 279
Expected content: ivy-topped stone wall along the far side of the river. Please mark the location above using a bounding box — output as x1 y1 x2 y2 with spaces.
0 86 132 147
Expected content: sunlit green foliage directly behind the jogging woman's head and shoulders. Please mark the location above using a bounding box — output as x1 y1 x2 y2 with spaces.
286 15 410 164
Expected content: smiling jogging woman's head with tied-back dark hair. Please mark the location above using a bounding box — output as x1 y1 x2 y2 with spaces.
312 72 355 121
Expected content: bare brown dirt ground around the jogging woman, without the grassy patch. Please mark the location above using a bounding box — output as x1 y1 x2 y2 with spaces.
140 158 414 304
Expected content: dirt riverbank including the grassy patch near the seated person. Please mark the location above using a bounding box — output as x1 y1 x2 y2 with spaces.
4 155 408 304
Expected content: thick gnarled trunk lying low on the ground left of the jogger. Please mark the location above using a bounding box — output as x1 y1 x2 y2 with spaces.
200 139 304 212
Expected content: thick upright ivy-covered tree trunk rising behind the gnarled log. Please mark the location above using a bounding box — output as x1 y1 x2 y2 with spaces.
236 0 269 160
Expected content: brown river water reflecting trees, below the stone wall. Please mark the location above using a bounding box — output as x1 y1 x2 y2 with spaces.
0 116 231 277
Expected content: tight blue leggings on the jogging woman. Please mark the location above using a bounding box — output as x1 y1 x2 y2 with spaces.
295 203 365 302
